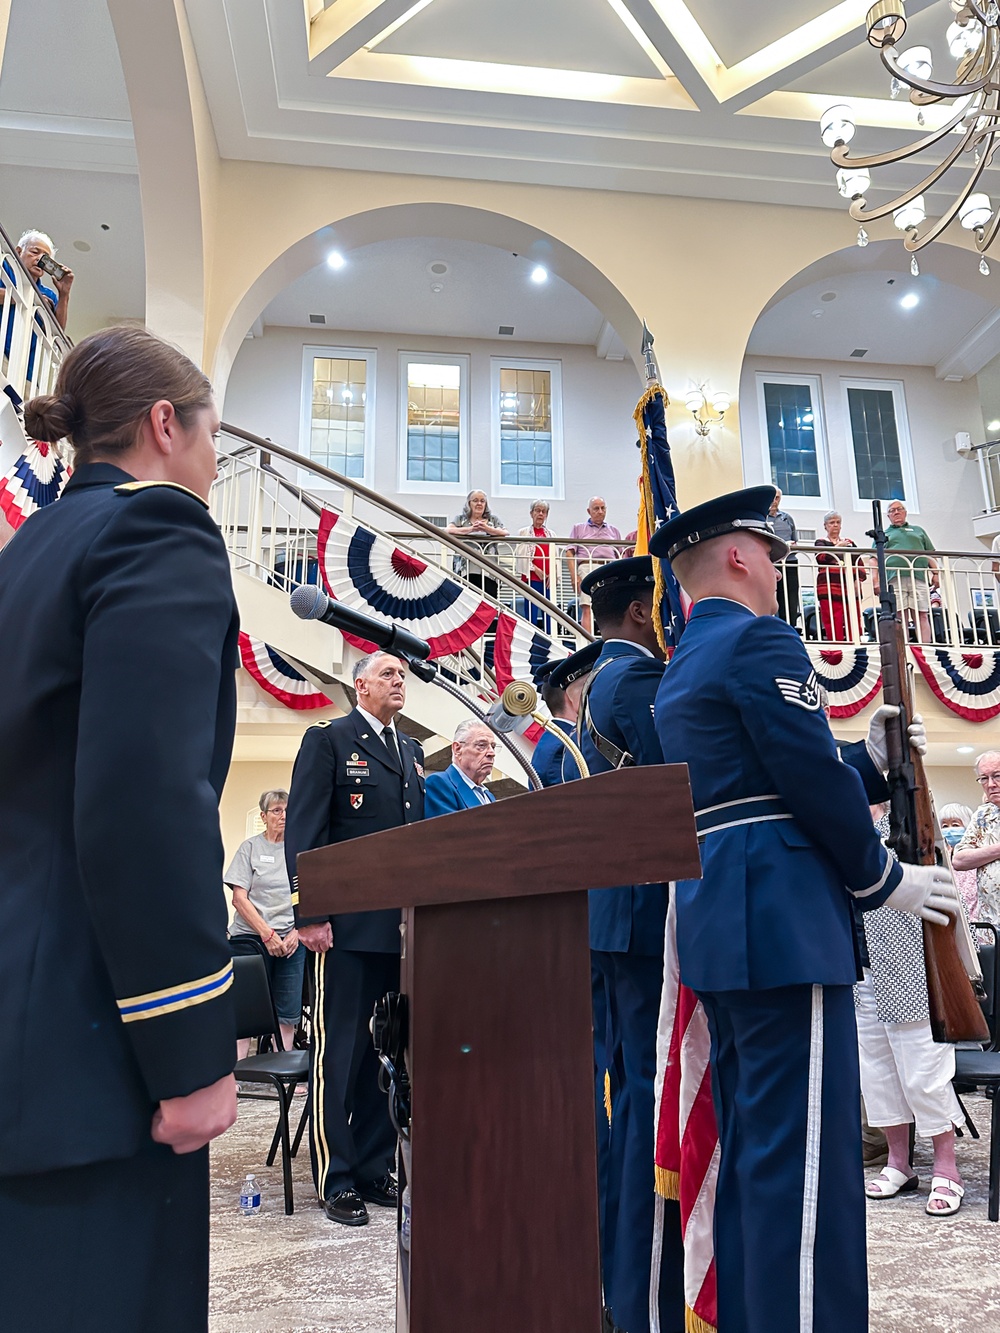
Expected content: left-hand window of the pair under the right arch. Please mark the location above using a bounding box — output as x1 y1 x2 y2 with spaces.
757 375 827 508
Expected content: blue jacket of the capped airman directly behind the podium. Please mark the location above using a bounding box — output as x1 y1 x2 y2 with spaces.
580 639 667 956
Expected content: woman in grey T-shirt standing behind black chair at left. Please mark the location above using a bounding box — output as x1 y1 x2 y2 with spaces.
225 790 305 1055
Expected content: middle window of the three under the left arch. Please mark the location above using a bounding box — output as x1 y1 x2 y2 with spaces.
399 352 469 495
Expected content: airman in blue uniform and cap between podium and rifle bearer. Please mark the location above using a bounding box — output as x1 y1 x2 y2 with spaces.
580 556 684 1333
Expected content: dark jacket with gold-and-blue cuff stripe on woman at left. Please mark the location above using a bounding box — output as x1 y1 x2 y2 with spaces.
0 463 239 1174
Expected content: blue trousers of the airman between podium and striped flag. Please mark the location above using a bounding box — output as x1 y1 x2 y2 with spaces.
591 950 684 1333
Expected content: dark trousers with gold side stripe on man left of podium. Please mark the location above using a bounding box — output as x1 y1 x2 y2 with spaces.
309 948 399 1200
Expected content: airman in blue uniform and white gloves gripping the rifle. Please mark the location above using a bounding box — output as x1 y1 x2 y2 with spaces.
649 487 956 1333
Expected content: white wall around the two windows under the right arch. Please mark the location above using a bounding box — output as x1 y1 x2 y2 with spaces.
740 356 983 551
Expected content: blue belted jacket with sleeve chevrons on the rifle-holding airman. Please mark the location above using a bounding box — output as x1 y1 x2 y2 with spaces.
656 597 901 990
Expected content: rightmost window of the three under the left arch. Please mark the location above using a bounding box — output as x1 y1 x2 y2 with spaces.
492 357 563 497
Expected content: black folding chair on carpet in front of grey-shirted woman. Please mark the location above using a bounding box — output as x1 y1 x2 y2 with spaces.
232 956 309 1213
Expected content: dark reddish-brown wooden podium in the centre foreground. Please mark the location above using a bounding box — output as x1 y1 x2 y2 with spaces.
299 765 701 1333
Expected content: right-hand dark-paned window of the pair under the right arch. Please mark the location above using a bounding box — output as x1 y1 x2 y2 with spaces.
843 380 916 508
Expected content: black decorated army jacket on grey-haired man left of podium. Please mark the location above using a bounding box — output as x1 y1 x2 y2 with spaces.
285 708 424 953
